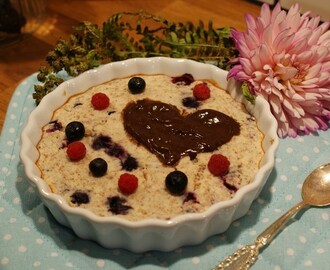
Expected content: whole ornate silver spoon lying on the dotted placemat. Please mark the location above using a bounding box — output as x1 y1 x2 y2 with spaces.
212 163 330 270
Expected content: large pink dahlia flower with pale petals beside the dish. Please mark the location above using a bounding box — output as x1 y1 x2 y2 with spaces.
228 4 330 137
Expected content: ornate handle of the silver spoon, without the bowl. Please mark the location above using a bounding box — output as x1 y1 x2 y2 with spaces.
212 201 307 270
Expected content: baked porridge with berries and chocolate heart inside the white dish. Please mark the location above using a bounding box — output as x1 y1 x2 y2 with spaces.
36 74 264 221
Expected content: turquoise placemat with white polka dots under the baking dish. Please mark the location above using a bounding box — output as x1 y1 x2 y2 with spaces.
0 74 330 270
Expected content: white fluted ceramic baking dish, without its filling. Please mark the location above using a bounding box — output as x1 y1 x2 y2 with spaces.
20 57 278 252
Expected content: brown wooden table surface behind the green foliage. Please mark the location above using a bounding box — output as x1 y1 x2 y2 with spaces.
0 0 260 134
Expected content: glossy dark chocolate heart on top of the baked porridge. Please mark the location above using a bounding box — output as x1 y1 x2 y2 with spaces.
123 99 240 165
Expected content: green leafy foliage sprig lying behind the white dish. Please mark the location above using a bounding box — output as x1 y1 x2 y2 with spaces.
33 11 238 104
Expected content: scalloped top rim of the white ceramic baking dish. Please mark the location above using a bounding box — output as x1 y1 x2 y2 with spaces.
20 57 279 228
